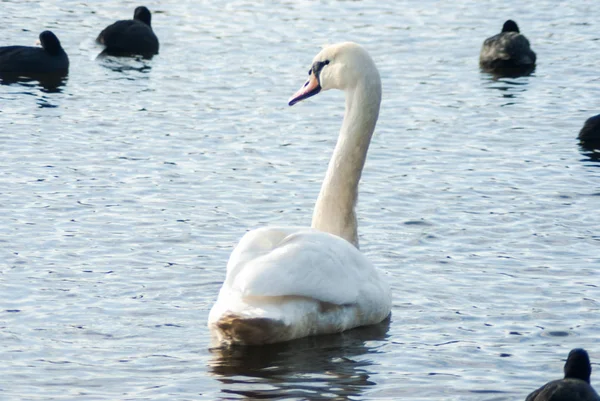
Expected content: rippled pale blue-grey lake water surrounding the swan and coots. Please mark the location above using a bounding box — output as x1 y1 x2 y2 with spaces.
0 0 600 401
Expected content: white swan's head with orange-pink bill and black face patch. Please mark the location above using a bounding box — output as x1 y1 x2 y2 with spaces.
289 42 379 106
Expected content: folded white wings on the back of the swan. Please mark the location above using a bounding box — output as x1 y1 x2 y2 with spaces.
225 228 380 305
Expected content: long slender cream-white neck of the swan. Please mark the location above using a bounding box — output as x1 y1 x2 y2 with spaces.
312 77 381 248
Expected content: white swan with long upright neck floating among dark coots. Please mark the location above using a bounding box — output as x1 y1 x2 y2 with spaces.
208 42 391 345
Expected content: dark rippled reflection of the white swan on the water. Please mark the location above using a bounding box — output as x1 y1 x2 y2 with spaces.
209 317 390 400
